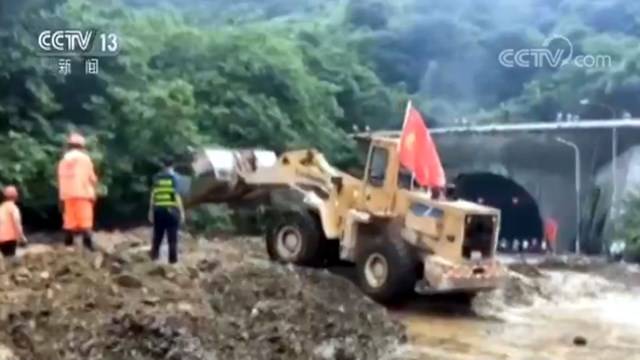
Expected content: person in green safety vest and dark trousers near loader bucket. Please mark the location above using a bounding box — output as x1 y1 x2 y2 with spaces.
149 159 185 264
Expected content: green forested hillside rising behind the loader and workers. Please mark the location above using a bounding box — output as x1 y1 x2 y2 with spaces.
0 0 640 225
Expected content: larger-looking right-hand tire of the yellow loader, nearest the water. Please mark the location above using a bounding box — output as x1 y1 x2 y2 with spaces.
356 228 417 305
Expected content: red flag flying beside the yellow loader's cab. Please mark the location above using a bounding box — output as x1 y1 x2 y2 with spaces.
399 102 446 187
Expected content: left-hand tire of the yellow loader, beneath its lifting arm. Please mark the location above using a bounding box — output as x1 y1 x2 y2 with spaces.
266 212 323 266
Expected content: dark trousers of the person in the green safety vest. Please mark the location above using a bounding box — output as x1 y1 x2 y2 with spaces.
151 208 180 264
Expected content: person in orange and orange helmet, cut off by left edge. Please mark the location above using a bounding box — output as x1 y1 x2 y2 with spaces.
0 186 27 258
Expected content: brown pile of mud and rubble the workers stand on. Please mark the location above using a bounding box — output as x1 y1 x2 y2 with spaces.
0 230 404 360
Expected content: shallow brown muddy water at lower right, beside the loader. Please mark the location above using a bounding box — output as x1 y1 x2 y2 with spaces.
390 271 640 360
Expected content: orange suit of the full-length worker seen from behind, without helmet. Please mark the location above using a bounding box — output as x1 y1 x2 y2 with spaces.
58 149 98 231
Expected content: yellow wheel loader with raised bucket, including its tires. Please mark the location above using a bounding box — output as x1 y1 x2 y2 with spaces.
185 132 505 303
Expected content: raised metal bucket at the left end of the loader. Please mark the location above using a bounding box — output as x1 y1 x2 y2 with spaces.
185 148 277 207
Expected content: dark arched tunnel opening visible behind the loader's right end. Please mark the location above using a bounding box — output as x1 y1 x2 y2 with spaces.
455 173 548 253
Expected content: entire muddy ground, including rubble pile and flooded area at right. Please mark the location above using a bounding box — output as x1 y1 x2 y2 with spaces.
0 229 640 360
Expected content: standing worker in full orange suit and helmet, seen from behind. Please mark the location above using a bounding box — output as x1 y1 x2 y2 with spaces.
58 133 98 251
